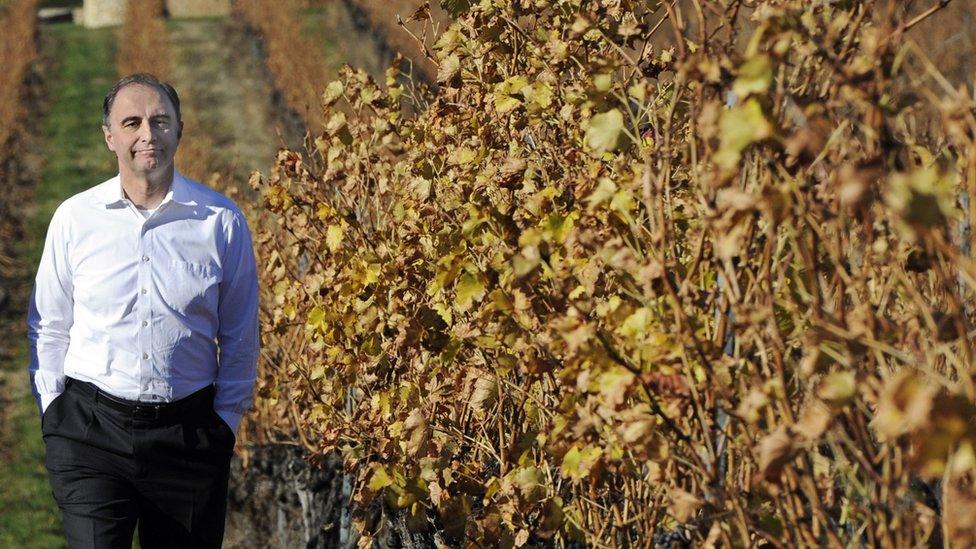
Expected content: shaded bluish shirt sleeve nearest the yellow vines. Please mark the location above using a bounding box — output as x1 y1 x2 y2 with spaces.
214 212 260 433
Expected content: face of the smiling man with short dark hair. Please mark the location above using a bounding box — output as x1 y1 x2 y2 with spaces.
102 84 183 177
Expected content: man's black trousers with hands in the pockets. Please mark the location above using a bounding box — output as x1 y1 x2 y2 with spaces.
41 378 234 549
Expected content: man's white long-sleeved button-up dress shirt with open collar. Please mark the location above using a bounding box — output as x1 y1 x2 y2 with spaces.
27 172 259 433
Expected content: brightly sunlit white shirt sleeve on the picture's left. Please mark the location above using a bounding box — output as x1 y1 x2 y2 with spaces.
27 204 74 414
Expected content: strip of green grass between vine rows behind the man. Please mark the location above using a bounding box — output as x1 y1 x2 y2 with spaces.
0 20 116 548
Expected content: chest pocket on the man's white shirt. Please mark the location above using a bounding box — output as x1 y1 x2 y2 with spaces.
158 260 222 316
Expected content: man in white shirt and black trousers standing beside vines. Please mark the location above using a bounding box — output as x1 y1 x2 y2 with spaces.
27 74 258 548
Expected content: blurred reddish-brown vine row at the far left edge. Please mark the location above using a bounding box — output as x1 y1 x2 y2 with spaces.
0 0 38 310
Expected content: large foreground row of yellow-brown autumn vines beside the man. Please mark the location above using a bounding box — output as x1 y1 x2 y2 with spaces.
242 0 976 547
